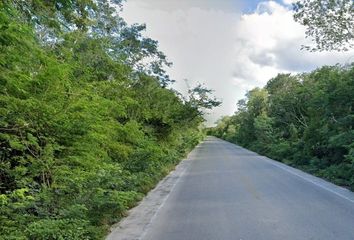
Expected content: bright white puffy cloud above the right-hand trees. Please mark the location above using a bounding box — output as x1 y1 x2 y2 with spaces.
233 1 354 101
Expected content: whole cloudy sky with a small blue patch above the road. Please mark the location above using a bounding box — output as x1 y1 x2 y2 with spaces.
122 0 354 125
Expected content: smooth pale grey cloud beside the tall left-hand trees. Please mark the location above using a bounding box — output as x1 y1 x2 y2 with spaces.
123 0 240 122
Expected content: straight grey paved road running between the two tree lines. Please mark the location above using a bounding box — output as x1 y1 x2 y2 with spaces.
142 137 354 240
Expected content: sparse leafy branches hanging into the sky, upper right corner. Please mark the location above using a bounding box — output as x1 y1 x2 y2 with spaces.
293 0 354 51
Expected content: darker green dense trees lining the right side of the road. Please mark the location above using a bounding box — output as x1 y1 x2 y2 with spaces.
210 65 354 190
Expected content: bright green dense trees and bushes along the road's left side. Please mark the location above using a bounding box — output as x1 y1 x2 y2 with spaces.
0 0 219 240
